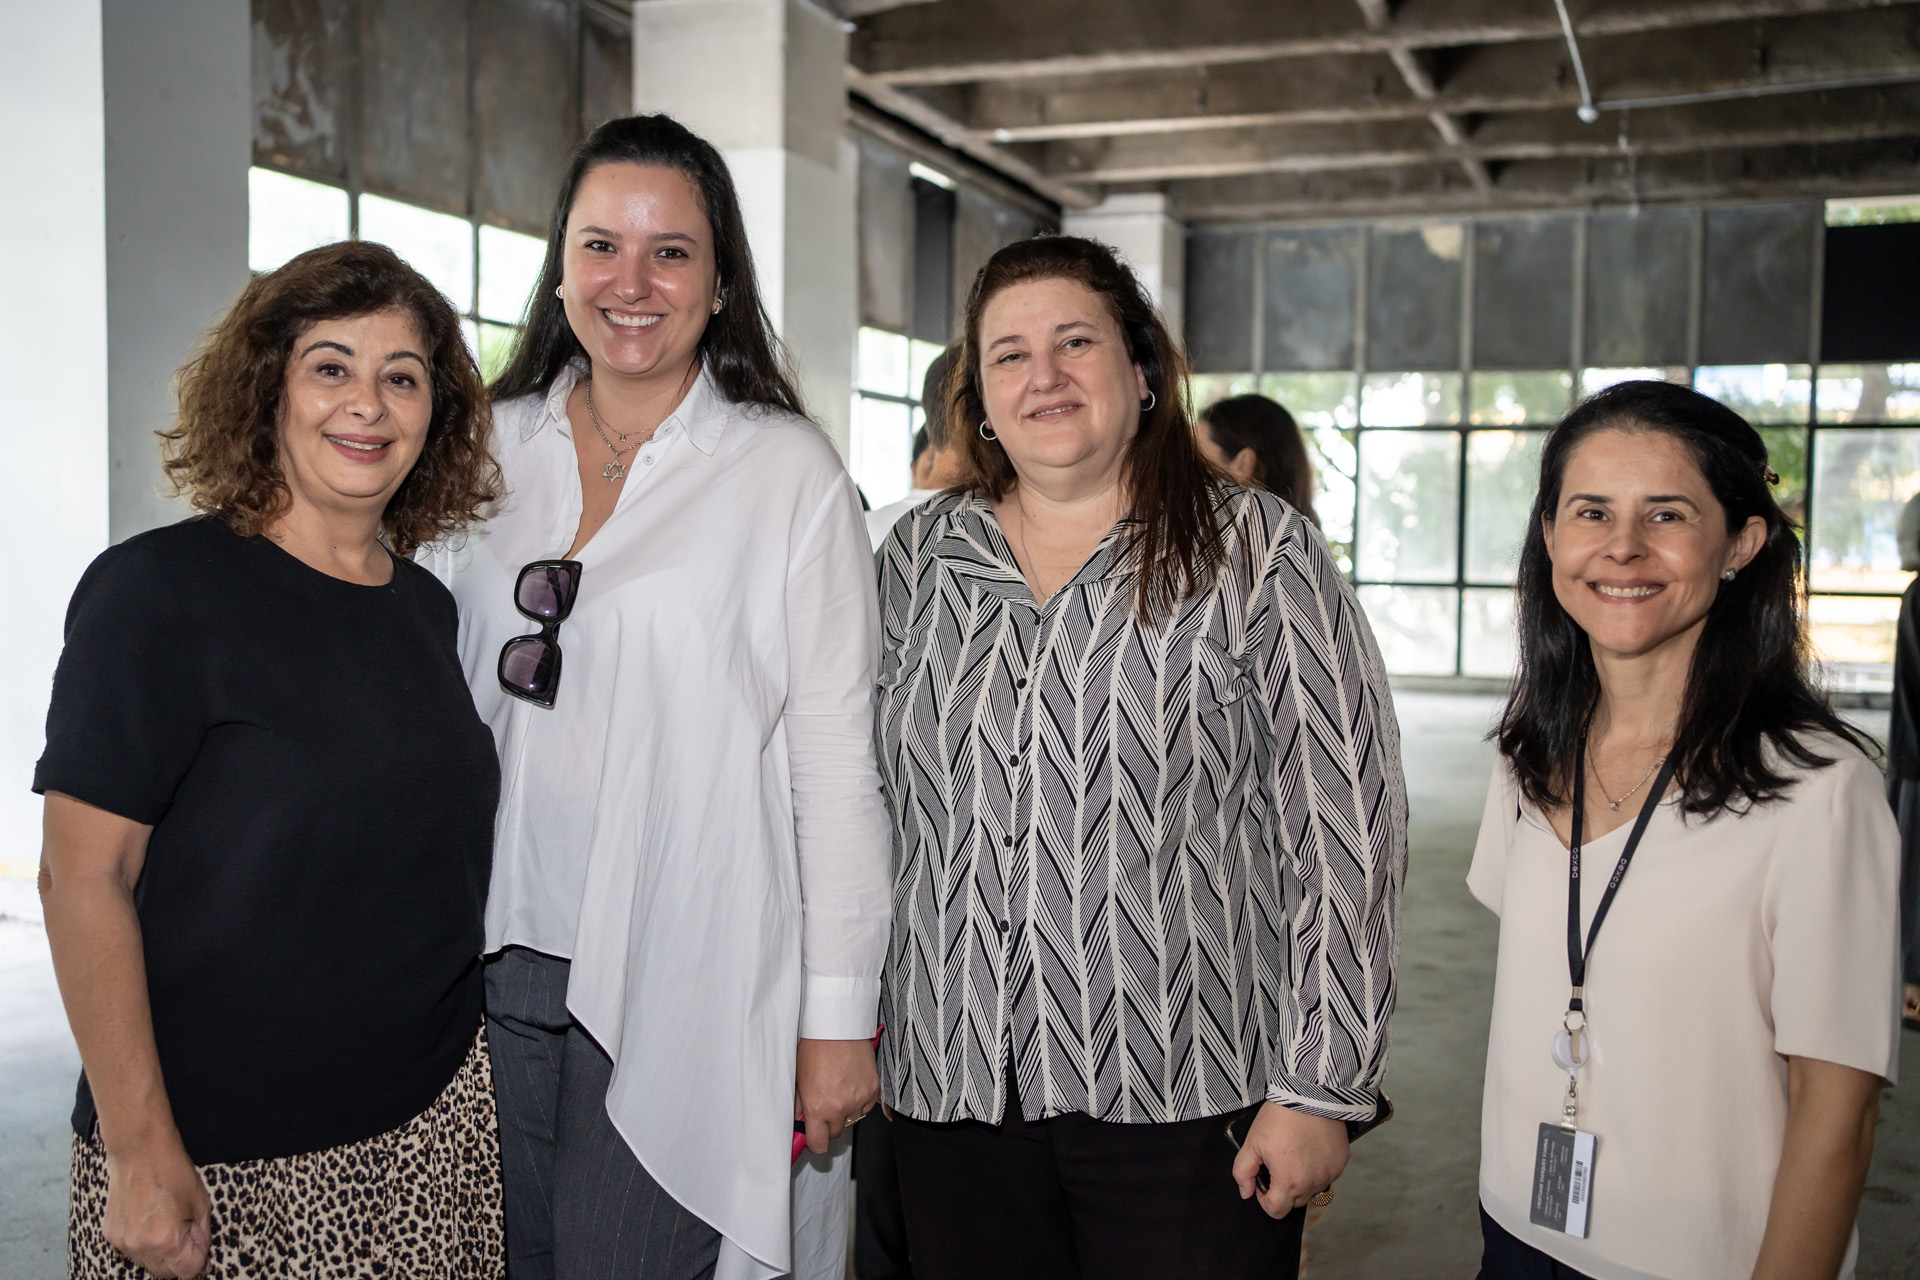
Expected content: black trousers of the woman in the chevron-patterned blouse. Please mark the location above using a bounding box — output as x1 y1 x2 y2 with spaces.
893 1092 1306 1280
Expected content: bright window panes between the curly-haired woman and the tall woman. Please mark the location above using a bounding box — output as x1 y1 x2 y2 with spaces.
248 165 547 380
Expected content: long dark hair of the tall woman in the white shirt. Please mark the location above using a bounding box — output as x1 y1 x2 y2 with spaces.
488 115 806 416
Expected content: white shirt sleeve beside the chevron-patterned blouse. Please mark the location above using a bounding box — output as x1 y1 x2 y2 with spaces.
781 474 891 1040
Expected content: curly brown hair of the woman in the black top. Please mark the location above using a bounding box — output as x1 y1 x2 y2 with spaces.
157 240 503 555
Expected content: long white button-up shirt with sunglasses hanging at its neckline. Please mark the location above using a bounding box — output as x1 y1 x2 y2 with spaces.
420 365 889 1274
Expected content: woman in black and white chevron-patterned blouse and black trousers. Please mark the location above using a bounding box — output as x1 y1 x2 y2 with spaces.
877 236 1405 1280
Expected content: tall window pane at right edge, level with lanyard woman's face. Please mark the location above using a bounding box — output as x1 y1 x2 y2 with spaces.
1811 428 1920 593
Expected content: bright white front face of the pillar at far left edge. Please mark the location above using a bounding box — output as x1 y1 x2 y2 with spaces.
0 0 108 859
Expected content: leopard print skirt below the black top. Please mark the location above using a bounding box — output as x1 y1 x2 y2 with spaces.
67 1029 507 1280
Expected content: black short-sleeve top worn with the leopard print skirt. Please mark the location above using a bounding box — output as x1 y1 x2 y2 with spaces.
33 518 499 1165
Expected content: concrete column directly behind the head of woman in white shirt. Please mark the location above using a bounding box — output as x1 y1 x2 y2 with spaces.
634 0 860 455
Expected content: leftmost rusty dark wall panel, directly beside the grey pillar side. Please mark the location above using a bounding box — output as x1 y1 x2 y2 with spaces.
253 0 353 182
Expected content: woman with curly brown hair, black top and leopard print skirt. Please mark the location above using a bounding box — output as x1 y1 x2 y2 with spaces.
35 242 503 1278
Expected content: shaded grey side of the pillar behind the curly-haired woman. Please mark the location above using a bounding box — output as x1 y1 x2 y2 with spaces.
104 0 253 541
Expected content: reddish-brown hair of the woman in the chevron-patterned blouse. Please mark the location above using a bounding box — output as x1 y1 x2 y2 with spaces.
947 236 1225 622
